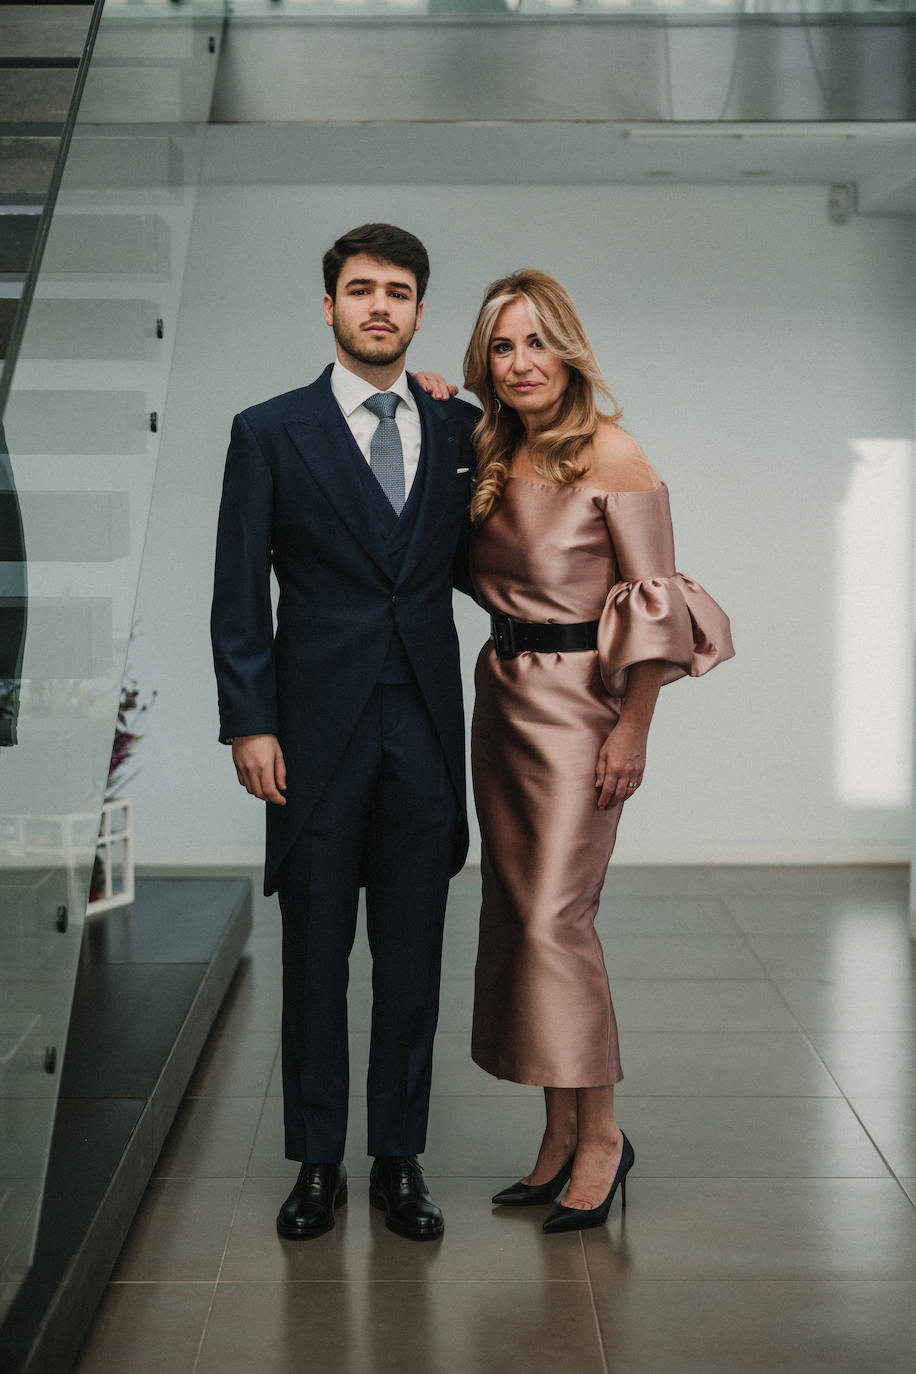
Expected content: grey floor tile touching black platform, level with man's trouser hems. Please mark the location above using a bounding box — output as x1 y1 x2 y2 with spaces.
152 1096 264 1178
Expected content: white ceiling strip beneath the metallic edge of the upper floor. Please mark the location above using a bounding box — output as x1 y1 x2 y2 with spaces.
206 122 916 216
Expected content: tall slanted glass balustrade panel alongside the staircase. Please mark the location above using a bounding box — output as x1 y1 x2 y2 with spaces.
0 5 221 1316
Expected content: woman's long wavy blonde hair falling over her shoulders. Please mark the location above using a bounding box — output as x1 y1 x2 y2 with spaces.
464 267 623 525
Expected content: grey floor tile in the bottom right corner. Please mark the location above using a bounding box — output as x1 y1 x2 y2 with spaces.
595 1281 916 1374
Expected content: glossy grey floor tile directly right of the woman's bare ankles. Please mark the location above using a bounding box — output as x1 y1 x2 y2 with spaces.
617 1094 887 1186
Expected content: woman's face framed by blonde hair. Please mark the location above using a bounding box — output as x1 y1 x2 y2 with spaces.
488 297 570 429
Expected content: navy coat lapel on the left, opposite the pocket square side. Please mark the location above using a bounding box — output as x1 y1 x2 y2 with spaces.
286 365 391 577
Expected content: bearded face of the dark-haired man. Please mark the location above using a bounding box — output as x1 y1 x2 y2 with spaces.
324 253 423 367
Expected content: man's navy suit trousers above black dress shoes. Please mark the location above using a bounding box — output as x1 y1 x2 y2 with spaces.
279 683 457 1164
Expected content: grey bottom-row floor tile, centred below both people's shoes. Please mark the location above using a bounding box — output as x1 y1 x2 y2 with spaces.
199 1282 604 1374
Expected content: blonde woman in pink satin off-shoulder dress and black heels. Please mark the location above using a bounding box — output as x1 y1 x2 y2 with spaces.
464 269 733 1232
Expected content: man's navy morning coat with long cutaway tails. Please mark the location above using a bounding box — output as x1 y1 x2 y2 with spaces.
210 367 479 893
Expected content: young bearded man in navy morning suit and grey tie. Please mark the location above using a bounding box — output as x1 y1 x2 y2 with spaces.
211 224 477 1239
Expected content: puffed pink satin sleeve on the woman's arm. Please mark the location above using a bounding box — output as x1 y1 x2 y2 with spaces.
597 486 735 697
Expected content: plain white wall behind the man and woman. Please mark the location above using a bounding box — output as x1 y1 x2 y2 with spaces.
132 155 916 863
